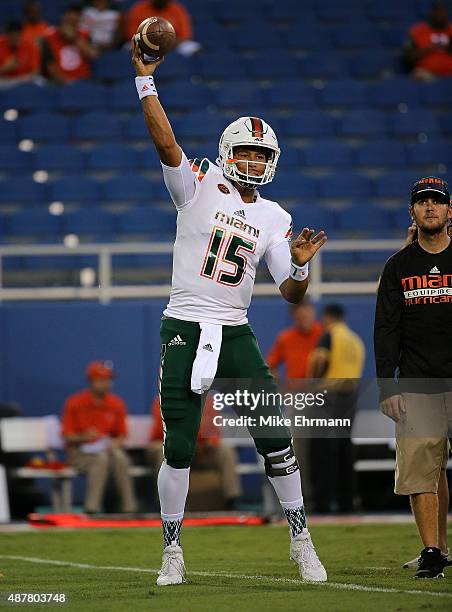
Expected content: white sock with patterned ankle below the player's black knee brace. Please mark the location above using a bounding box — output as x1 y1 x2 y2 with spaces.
268 448 308 538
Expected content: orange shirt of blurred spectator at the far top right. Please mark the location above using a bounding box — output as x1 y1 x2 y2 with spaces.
410 23 452 76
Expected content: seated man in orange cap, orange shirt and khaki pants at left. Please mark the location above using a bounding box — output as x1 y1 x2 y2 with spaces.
62 361 136 513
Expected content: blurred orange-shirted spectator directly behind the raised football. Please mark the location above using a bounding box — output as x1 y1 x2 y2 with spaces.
126 0 201 55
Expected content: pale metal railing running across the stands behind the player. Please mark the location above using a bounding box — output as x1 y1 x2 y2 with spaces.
0 240 402 304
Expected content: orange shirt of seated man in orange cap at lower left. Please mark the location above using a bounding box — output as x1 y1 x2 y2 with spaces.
62 389 127 438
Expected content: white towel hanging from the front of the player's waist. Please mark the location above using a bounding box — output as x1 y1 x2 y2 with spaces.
191 323 223 395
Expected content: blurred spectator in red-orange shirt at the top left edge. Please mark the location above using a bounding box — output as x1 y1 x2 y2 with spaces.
0 21 41 85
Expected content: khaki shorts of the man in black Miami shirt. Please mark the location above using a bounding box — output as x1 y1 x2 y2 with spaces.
394 393 452 495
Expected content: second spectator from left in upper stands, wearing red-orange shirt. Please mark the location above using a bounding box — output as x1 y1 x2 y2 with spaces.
43 6 98 83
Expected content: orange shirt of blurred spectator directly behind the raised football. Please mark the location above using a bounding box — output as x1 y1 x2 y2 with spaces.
126 0 193 41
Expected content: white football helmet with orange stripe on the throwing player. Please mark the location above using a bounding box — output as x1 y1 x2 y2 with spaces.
217 117 281 187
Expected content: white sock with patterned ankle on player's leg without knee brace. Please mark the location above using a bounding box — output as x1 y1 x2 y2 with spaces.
157 461 190 547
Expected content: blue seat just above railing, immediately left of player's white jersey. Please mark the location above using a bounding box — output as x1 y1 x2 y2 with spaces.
118 205 176 236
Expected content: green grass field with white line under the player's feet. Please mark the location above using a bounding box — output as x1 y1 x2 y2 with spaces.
0 524 452 612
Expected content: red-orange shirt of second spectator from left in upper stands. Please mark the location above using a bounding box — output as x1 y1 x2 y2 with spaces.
44 28 91 81
